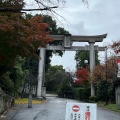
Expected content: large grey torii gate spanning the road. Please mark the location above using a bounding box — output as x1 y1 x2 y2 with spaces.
37 34 107 98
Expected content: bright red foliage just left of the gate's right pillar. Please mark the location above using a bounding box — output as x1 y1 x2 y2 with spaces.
76 68 88 84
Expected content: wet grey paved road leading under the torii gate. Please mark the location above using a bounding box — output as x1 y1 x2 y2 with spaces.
2 96 120 120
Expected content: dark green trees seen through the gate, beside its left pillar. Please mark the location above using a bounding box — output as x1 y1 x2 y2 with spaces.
45 65 74 98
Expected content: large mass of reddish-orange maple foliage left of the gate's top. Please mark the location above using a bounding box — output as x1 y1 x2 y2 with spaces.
0 14 52 66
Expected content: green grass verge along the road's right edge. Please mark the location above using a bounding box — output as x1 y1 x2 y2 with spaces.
98 102 120 113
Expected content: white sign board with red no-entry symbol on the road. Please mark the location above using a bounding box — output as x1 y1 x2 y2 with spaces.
65 103 97 120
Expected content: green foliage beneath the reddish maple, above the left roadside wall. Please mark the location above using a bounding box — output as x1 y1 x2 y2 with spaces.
0 56 28 95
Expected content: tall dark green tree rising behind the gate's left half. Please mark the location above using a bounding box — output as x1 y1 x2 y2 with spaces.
40 15 69 70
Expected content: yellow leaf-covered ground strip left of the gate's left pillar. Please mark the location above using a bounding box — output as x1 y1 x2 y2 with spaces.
15 98 44 104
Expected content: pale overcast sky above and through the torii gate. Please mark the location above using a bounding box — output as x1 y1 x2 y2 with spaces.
24 0 120 71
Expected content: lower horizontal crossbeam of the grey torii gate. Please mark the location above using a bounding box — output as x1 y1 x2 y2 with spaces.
45 45 105 51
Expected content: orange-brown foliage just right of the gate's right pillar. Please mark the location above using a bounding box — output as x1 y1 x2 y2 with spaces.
92 57 117 84
